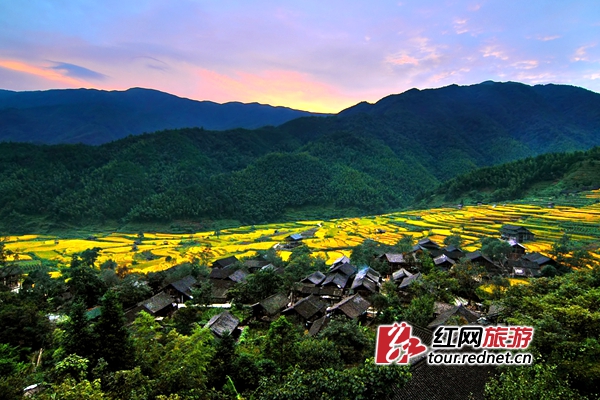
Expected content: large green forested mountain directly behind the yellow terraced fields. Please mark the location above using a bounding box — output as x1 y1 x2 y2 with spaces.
0 82 600 232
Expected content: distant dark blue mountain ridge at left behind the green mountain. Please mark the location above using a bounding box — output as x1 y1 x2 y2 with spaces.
0 88 326 145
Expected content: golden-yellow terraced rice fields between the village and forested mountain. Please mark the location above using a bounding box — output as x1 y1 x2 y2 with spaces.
5 197 600 272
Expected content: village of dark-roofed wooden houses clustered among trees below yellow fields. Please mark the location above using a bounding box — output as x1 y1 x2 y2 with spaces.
117 225 557 337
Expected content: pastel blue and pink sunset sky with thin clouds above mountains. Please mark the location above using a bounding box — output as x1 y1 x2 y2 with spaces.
0 0 600 112
